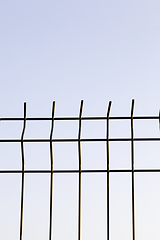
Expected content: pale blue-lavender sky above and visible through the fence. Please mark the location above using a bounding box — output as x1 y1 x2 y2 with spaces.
0 0 160 240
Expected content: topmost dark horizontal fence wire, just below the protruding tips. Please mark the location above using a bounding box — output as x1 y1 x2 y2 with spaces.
0 116 159 121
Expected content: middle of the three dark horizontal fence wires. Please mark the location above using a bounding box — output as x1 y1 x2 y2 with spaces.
0 138 160 142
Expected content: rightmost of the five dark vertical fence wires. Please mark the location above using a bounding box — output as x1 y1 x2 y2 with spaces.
131 99 135 240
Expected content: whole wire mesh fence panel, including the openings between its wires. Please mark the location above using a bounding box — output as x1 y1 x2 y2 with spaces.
0 100 160 240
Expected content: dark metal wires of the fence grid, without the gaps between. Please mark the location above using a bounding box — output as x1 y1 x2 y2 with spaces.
0 99 160 240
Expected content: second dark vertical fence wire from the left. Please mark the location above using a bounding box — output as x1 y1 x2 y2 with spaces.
49 102 55 240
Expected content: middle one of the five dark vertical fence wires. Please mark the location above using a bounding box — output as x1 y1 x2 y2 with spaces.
78 100 83 240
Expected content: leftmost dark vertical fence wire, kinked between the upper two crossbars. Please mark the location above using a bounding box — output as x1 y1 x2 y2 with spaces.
20 102 26 240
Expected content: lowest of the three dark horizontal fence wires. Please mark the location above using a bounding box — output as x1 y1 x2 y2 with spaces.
0 169 160 173
